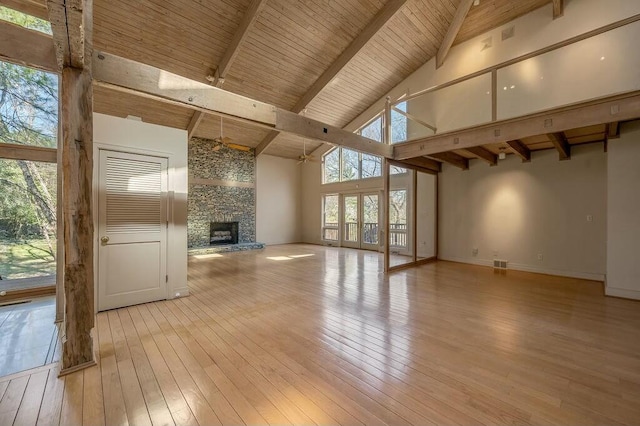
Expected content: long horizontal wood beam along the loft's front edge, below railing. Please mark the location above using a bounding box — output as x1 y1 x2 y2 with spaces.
394 91 640 160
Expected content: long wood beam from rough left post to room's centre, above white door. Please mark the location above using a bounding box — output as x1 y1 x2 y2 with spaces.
93 52 393 158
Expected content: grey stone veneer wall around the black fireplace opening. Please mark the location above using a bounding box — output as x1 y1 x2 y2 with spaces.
187 138 256 247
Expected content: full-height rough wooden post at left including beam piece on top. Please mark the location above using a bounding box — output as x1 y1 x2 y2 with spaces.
47 0 95 375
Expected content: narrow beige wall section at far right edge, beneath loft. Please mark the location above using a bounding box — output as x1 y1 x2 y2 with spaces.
605 121 640 299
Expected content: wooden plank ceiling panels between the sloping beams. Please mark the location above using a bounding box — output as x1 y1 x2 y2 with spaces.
5 0 564 158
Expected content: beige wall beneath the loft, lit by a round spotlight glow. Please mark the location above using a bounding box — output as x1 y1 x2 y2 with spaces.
438 144 607 280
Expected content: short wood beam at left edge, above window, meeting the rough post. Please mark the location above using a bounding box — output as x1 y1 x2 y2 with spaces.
0 20 58 72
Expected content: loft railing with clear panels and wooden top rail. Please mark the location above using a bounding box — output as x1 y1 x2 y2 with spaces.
384 15 640 143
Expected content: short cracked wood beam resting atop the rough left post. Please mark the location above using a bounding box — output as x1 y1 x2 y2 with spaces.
47 0 86 69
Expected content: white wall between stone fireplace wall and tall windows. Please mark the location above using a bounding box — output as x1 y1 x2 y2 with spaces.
256 155 302 244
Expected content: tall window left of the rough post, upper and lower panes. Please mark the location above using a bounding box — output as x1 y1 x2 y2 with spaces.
0 58 58 290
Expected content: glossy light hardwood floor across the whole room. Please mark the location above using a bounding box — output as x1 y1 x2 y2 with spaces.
0 245 640 425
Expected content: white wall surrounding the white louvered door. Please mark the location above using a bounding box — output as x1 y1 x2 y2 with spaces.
93 113 189 298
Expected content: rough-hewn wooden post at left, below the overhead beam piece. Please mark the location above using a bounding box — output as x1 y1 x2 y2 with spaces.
60 67 95 375
